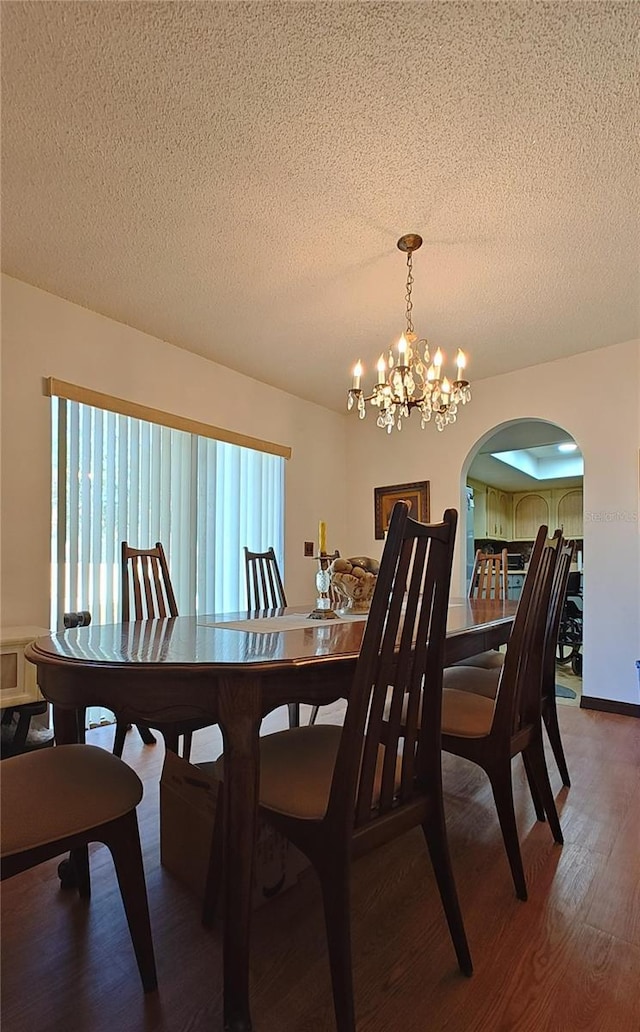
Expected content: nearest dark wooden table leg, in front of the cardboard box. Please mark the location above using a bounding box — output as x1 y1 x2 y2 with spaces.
219 678 261 1032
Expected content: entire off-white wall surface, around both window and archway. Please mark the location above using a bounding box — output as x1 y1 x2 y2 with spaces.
0 277 640 704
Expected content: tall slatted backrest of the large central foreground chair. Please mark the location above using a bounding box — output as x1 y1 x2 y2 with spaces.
327 502 457 828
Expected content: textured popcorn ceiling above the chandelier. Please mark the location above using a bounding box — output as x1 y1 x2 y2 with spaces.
0 0 640 410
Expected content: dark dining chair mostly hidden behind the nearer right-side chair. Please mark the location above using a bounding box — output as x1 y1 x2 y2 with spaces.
444 530 576 784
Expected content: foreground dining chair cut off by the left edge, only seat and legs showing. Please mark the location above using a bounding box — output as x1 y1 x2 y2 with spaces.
0 745 157 993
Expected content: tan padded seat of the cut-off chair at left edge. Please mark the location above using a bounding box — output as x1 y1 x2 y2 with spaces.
0 745 142 857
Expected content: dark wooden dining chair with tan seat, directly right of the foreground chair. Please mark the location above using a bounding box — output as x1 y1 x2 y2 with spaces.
442 526 563 900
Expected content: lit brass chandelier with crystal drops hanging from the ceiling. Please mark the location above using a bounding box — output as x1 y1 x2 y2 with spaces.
347 233 471 433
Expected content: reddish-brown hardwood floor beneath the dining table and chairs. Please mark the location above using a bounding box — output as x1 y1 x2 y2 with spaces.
0 706 640 1032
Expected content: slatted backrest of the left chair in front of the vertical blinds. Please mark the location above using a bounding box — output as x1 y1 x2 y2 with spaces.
121 541 178 622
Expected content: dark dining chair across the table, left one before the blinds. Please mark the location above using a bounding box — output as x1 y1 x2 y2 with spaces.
114 541 206 760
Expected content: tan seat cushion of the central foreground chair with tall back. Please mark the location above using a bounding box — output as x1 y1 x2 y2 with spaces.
215 723 402 820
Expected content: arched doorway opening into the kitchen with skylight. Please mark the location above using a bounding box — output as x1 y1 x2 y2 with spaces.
461 418 583 703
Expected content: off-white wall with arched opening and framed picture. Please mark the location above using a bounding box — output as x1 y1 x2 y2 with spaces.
346 341 640 704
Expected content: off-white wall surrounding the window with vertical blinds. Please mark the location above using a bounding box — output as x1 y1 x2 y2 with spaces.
0 276 347 626
